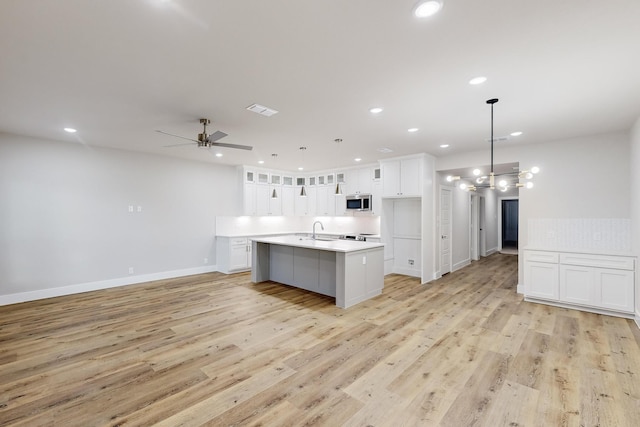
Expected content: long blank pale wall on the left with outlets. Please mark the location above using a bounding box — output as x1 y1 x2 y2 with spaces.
0 134 240 303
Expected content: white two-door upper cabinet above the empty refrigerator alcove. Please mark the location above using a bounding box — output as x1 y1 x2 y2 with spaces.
380 158 422 197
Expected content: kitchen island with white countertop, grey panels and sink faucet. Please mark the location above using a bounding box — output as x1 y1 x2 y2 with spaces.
251 235 384 308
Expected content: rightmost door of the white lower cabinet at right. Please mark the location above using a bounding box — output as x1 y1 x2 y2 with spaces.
594 268 634 313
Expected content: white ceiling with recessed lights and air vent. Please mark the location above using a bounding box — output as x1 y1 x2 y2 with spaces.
0 0 640 171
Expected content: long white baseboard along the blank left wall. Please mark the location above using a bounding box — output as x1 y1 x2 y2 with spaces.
0 265 217 305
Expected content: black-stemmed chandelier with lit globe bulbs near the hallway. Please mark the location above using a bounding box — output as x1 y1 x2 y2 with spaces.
447 98 540 192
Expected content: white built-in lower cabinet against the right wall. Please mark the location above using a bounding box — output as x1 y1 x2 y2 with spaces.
524 250 635 315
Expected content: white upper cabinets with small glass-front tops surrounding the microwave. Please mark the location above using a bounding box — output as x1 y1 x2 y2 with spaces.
240 166 381 216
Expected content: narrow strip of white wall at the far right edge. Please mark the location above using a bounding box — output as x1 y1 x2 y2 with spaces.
629 117 640 326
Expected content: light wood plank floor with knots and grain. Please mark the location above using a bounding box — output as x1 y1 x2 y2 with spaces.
0 254 640 427
